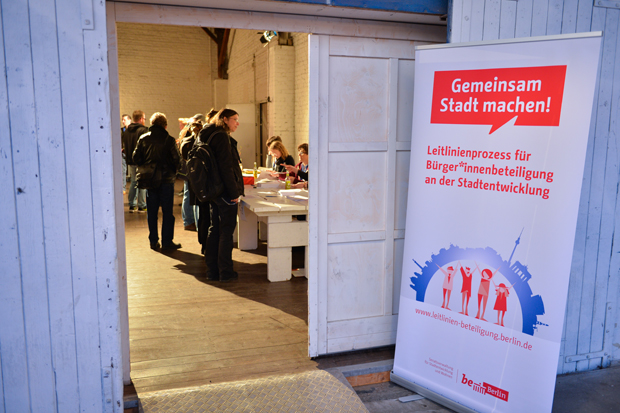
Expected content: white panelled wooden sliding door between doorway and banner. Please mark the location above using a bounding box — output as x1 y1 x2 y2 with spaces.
308 35 423 356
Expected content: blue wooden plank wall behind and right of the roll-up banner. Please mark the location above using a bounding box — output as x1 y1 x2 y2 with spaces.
448 0 620 373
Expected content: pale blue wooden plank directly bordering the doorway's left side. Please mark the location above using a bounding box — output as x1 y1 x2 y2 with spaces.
83 2 123 411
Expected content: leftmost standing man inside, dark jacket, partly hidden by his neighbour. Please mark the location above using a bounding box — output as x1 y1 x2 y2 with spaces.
121 110 149 213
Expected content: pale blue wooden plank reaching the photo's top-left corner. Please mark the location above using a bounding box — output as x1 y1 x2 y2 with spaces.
2 1 56 411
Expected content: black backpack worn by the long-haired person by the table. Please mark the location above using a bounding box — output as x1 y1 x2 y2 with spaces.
187 131 224 202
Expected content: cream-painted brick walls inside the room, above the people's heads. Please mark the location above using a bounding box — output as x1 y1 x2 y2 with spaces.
117 23 308 150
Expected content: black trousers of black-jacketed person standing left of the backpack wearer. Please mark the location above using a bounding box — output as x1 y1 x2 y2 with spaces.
146 183 174 246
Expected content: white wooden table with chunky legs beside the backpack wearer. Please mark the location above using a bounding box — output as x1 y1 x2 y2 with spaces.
237 185 308 282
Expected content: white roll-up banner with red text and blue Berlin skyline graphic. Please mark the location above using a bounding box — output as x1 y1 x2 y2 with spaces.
392 33 601 412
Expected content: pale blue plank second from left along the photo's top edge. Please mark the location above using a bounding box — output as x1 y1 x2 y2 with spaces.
30 1 80 411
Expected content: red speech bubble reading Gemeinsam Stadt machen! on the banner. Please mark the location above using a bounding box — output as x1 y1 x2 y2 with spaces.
431 66 566 134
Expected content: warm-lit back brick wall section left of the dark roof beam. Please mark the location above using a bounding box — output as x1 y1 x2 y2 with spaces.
117 23 217 137
